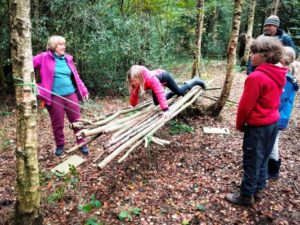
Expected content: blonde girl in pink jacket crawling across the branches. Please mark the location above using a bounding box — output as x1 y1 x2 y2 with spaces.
127 65 206 117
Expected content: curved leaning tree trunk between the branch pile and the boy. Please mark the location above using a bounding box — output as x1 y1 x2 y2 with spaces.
207 0 243 117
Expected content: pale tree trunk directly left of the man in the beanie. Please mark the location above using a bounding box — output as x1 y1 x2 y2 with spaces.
241 0 256 65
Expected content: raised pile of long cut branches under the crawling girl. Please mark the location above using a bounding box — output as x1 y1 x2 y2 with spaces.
67 86 209 169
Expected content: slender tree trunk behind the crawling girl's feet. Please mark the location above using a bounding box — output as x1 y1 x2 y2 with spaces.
191 0 204 78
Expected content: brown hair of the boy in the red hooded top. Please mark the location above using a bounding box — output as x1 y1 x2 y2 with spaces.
250 36 283 64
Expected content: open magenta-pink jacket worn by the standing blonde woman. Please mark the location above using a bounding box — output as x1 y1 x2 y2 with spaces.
33 51 88 105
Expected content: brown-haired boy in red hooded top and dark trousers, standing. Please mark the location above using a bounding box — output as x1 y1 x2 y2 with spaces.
225 37 287 206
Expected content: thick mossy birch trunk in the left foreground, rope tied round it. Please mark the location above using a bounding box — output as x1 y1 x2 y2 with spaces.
9 0 42 225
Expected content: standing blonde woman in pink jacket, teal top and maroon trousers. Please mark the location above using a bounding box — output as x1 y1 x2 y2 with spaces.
33 36 89 156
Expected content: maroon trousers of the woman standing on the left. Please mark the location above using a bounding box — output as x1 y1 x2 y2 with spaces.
46 93 84 146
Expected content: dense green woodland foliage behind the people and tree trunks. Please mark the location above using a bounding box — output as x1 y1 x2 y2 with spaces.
0 0 300 98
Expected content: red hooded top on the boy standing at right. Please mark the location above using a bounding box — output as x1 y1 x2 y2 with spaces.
236 63 288 131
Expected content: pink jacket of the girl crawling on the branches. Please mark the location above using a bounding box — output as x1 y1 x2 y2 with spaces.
130 66 169 111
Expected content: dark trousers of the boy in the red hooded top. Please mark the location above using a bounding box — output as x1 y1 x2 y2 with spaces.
241 122 278 196
